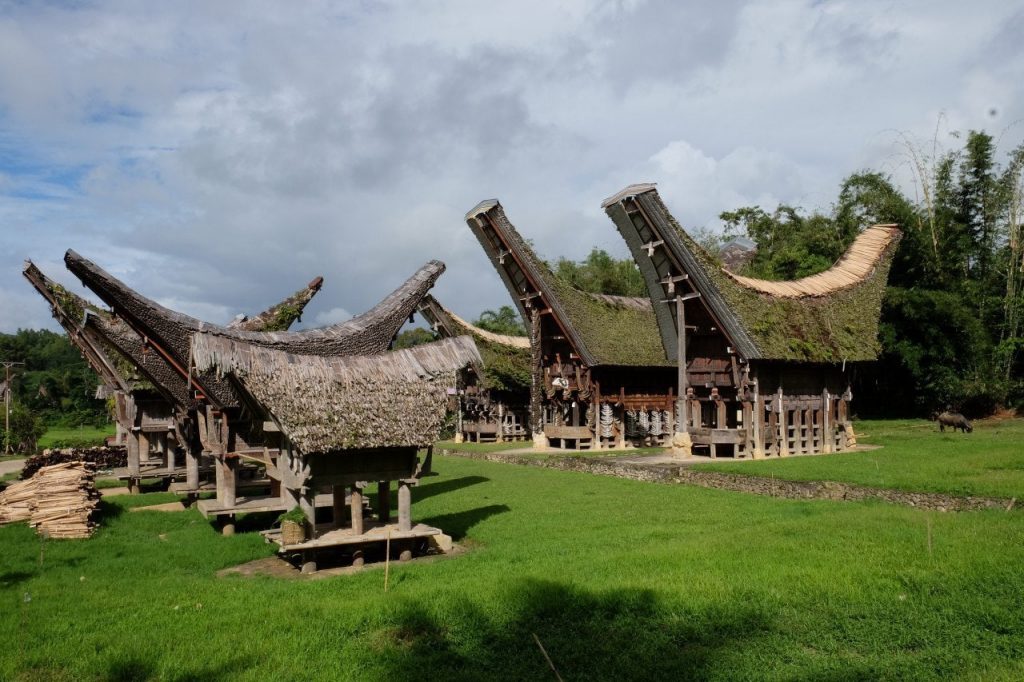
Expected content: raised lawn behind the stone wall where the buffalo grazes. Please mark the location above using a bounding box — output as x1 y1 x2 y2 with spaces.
696 419 1024 500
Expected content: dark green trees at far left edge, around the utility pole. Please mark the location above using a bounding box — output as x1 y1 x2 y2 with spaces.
0 330 108 426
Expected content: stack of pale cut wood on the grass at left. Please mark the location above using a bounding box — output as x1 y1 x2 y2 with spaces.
0 462 99 539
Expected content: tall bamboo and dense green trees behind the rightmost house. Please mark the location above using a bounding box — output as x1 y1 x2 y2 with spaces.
721 131 1024 415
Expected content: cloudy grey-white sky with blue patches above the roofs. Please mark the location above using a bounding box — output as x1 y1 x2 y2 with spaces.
0 0 1024 332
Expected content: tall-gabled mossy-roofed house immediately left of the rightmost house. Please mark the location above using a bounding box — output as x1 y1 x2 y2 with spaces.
466 200 676 449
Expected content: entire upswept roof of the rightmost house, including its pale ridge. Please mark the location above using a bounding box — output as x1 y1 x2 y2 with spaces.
602 184 900 363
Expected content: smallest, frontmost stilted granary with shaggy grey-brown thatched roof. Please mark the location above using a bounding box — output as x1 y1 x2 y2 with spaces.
191 334 480 570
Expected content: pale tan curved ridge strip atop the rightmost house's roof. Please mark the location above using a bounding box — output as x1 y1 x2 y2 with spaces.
722 224 900 298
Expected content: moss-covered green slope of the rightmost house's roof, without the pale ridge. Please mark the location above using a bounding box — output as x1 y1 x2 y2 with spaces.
606 185 900 363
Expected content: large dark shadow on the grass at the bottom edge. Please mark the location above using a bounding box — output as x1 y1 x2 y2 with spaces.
371 580 770 680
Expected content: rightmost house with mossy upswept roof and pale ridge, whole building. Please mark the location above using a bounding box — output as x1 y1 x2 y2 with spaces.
602 184 900 457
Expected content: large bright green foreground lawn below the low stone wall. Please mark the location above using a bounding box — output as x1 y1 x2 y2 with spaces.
0 457 1024 680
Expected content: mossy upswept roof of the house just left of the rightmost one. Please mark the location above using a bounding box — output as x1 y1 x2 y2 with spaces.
466 200 671 367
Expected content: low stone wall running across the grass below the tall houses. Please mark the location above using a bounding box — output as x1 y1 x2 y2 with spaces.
441 450 1015 512
